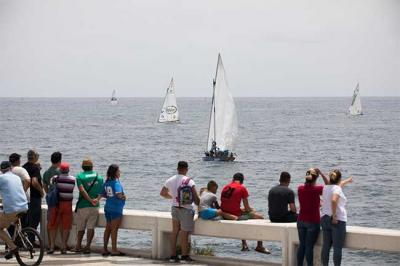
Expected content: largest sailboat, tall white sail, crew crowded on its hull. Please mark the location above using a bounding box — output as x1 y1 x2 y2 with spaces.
203 54 238 161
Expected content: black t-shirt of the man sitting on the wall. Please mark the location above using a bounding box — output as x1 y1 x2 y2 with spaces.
268 185 294 219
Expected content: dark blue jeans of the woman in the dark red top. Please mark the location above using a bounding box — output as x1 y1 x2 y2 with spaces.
297 221 320 266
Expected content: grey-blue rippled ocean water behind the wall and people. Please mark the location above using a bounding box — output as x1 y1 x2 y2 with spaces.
0 97 400 265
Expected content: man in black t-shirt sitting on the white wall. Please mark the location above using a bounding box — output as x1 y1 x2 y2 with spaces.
268 172 297 223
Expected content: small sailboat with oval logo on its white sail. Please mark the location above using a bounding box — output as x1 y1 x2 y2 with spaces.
158 78 179 123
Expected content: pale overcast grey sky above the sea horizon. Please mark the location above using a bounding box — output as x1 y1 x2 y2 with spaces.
0 0 400 97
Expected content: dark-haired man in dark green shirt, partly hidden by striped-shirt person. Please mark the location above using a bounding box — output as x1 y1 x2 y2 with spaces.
43 151 62 254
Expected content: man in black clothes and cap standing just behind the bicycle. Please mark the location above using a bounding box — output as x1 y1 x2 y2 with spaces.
23 150 44 242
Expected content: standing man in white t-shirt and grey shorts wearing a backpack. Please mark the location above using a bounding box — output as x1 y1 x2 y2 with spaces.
160 161 200 262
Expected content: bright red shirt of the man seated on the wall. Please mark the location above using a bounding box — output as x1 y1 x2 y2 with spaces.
221 182 249 216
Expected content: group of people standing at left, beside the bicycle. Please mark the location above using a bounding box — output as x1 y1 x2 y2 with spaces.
0 150 126 259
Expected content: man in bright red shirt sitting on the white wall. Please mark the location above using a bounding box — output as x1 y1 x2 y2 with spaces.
221 173 270 254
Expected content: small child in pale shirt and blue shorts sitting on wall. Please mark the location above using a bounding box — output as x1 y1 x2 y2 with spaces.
199 180 238 220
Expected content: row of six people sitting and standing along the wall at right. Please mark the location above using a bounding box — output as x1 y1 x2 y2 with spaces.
160 161 352 266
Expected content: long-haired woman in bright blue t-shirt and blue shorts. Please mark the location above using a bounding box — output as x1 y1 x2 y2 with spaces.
103 164 126 256
